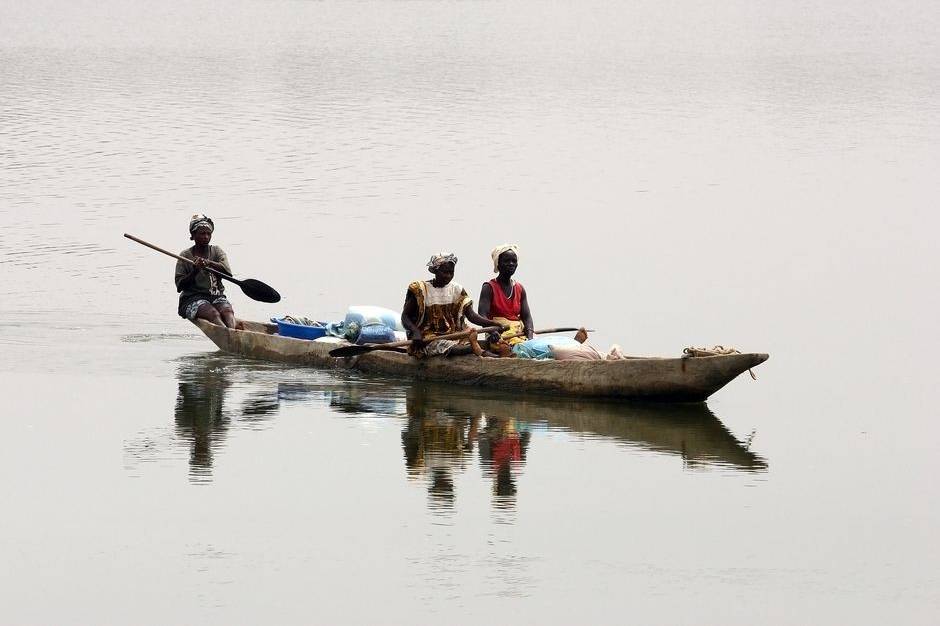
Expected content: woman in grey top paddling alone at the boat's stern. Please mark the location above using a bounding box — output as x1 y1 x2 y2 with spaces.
176 214 235 328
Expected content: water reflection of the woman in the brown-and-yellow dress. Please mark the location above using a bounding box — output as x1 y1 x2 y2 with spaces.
401 389 480 508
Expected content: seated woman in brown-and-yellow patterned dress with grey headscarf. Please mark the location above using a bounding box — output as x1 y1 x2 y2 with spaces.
401 252 499 357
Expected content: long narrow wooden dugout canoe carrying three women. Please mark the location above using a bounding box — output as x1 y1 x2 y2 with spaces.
196 320 768 402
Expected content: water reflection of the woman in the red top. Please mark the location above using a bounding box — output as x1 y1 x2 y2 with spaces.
479 416 532 507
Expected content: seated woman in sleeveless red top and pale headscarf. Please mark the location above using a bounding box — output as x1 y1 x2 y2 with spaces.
477 244 535 345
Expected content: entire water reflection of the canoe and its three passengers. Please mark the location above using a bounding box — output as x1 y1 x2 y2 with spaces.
174 354 767 488
